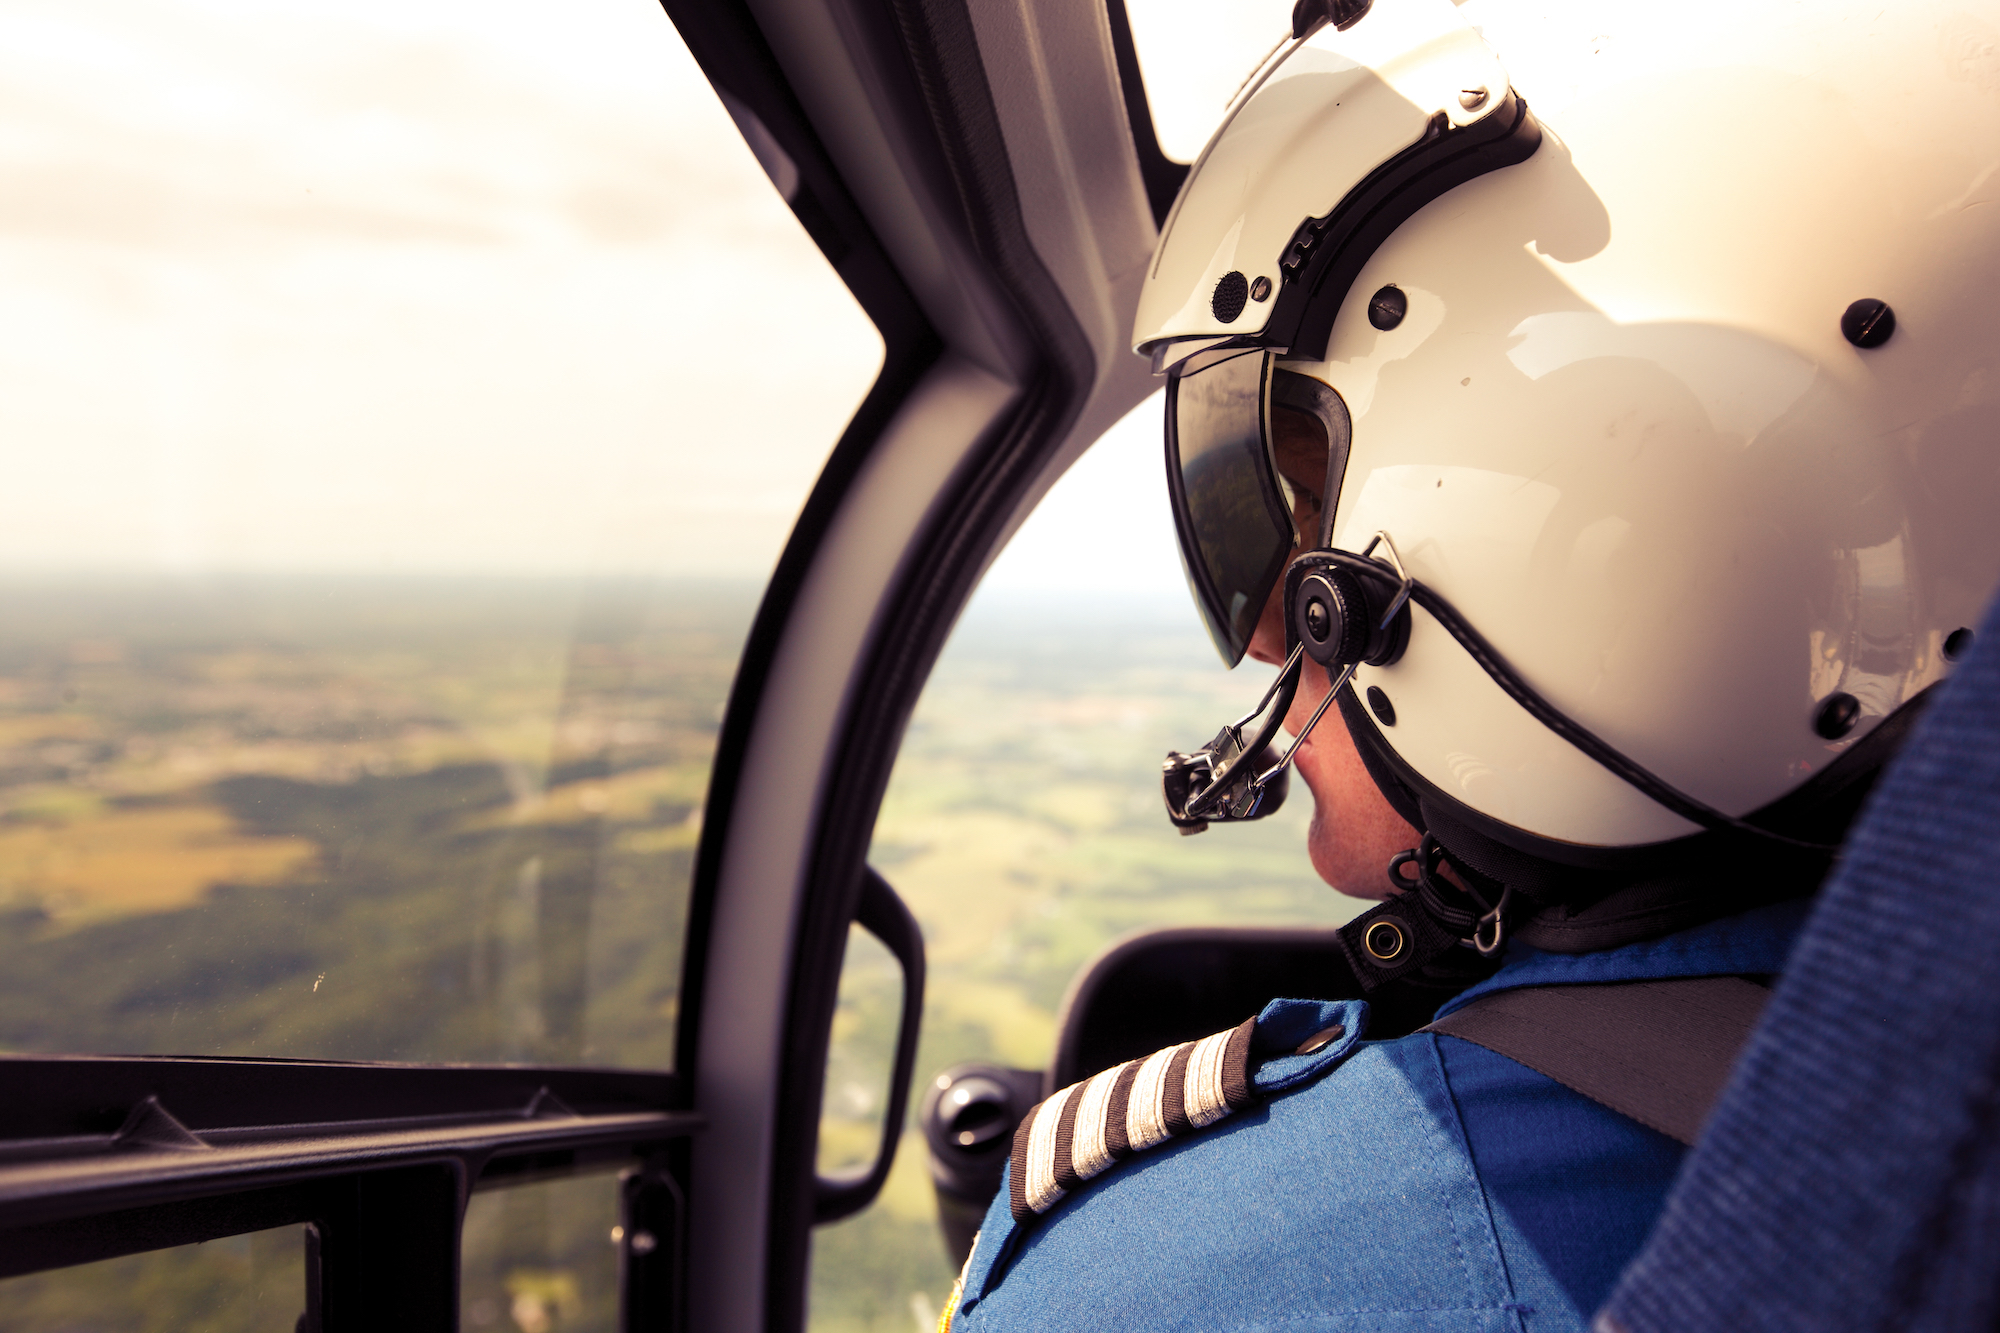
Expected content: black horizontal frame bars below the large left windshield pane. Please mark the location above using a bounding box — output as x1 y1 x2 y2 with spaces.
0 1055 700 1331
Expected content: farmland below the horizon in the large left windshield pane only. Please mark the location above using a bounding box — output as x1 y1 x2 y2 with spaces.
0 580 728 1065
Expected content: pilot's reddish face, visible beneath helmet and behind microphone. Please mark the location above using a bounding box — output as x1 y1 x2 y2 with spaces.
1250 406 1422 899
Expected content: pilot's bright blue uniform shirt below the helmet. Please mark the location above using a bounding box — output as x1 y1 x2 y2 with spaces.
950 903 1806 1333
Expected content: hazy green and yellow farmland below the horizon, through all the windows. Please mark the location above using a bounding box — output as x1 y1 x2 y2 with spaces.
0 578 1348 1333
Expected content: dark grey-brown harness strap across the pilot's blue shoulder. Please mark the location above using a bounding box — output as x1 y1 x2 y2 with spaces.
1418 977 1770 1145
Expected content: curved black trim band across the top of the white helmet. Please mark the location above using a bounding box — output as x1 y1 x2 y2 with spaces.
1256 92 1542 360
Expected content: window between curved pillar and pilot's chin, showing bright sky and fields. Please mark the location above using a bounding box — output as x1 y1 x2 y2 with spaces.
812 394 1354 1329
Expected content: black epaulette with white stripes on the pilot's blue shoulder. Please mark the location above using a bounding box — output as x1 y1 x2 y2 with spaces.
1008 1019 1258 1221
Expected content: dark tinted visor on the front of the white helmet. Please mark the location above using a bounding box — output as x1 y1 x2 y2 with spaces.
1166 350 1298 667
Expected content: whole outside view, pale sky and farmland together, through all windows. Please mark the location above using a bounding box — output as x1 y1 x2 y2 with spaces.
0 0 1340 1333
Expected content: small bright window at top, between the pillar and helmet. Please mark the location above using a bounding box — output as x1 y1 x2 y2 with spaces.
1126 0 1292 162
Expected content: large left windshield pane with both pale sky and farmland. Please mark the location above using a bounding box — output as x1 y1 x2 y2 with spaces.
0 0 882 1069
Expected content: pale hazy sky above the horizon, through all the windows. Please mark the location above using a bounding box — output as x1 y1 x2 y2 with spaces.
0 0 1288 590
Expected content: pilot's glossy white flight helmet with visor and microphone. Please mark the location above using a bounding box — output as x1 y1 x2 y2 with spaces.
1134 0 2000 947
